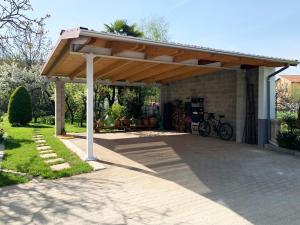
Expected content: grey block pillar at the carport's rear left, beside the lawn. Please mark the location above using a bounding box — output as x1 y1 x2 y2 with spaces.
55 80 65 136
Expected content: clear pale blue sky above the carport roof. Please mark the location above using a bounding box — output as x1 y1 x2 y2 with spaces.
31 0 300 74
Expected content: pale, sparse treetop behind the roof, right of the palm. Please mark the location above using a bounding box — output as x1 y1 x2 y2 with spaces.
140 17 169 41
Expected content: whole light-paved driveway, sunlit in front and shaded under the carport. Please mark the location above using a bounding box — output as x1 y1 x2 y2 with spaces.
0 132 300 225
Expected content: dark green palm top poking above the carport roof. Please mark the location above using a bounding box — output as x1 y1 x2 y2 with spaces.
104 20 143 37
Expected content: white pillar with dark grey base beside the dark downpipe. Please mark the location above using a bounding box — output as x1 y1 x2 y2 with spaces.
257 67 275 145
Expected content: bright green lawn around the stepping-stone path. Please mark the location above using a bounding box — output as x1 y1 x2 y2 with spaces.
2 119 92 183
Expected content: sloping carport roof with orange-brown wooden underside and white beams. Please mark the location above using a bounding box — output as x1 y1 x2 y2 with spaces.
42 28 299 83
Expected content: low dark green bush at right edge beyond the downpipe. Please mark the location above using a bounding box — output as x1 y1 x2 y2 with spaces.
277 131 300 150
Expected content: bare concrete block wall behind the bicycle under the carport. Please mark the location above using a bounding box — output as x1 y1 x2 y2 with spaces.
163 71 237 137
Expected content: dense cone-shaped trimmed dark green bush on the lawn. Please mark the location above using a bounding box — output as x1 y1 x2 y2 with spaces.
8 86 32 126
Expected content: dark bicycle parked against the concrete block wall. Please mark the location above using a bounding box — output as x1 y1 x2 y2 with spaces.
198 113 233 141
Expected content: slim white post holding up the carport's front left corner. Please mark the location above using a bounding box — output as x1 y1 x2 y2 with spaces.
85 54 94 161
